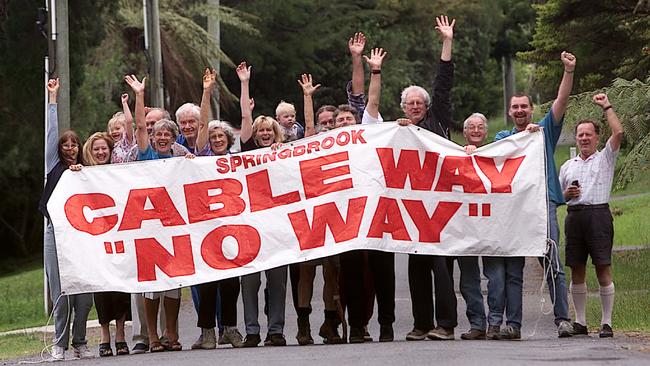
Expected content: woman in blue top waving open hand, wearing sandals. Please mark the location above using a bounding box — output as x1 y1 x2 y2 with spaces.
124 75 185 352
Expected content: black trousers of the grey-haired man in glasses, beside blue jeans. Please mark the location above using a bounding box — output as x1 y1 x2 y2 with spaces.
408 254 458 331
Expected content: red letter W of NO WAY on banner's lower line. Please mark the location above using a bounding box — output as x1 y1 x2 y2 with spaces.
288 197 368 250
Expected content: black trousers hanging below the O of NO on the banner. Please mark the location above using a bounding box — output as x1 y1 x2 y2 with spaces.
196 277 239 328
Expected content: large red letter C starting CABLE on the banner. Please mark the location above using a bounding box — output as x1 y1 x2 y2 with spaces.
63 193 117 235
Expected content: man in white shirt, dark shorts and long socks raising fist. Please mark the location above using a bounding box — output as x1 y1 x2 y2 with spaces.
560 94 623 338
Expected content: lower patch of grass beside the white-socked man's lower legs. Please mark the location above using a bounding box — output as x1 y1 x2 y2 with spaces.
587 249 650 332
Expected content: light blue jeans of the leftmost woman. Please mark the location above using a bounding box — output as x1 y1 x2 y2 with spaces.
43 222 93 349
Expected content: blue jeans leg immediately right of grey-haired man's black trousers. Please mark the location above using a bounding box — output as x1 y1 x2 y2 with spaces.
458 257 485 330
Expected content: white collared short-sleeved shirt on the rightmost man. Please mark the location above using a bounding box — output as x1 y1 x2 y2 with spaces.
560 140 619 206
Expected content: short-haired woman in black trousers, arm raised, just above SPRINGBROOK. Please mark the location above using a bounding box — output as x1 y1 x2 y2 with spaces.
192 69 243 349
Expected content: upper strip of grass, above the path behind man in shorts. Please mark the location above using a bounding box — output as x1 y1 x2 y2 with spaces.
557 194 650 247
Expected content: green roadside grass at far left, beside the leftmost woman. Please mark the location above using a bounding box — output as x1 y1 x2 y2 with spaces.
0 260 97 332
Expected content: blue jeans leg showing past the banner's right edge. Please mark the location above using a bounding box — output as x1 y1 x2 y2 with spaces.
539 201 571 325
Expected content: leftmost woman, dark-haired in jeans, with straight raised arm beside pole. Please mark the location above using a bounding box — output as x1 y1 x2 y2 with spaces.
38 79 93 361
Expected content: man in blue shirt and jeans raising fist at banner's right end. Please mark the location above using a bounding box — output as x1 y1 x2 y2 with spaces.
483 52 576 339
